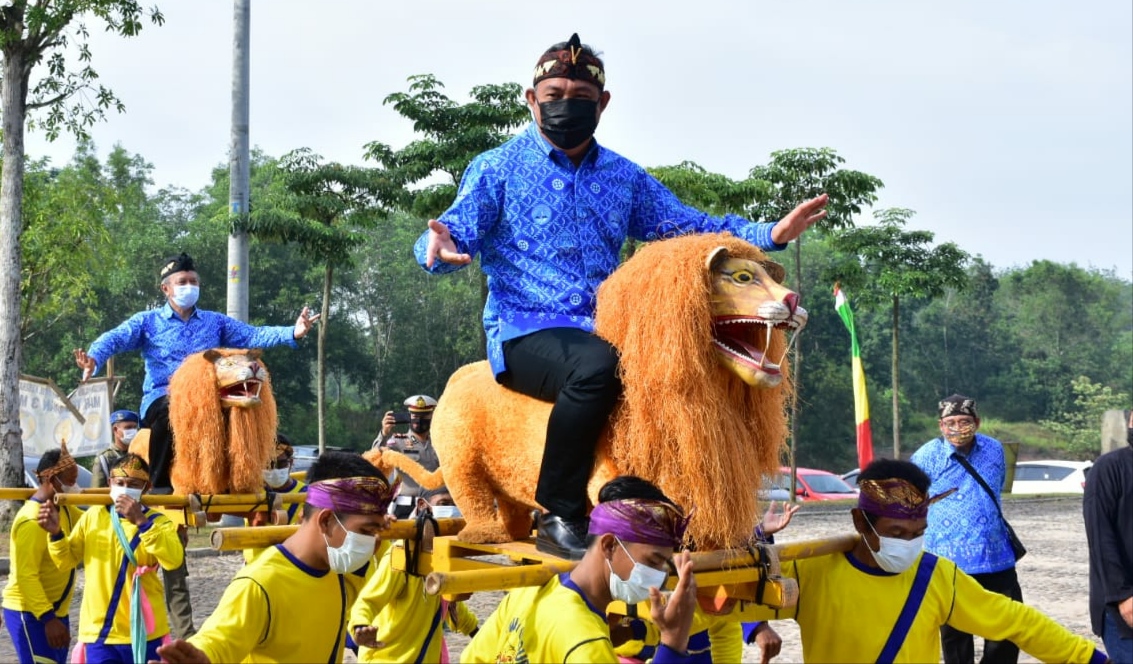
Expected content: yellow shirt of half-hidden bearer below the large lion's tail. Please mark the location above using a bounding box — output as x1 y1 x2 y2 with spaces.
350 547 476 662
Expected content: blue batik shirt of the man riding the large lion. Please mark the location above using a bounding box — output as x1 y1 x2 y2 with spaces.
414 124 786 375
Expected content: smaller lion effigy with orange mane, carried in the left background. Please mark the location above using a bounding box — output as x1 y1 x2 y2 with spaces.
169 348 276 494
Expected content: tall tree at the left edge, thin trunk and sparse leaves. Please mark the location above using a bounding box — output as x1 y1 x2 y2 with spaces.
0 0 164 525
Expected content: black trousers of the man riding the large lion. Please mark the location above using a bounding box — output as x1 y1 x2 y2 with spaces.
500 327 622 520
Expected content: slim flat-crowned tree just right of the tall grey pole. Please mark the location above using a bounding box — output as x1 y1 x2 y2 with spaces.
235 148 401 452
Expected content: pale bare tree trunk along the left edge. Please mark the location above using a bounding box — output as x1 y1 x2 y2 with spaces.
0 42 27 531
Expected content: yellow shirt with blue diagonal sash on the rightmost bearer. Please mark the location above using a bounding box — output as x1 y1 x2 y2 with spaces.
729 553 1094 663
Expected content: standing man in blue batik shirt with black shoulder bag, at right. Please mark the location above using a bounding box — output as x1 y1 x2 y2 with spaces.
912 394 1023 664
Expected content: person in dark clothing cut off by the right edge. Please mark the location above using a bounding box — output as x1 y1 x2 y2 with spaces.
1082 410 1133 664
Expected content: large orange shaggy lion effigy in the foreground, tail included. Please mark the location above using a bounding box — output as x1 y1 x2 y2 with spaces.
367 233 807 550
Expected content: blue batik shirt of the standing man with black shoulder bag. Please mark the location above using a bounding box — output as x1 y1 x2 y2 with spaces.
912 434 1015 574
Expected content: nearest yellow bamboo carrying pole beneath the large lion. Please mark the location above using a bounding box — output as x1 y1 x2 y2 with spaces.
425 534 860 596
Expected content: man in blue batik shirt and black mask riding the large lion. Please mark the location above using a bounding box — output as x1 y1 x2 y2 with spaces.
414 34 827 560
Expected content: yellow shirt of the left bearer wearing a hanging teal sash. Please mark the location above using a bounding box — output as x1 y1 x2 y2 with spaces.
48 505 185 645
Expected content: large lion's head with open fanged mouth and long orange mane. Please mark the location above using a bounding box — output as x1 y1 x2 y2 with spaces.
591 233 806 548
